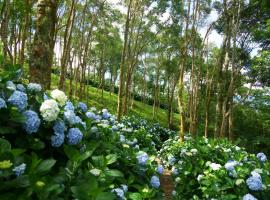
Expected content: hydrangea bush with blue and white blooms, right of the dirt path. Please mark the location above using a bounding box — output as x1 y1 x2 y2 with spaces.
159 137 270 200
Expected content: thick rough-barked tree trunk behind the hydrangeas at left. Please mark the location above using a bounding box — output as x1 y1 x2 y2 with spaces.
29 0 58 89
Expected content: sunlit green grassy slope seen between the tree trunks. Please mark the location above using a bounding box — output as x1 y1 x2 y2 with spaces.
52 74 179 127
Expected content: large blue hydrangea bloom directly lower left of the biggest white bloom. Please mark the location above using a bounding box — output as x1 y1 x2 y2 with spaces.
23 110 40 134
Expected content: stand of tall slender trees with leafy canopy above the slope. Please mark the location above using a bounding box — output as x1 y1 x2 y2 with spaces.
0 0 270 144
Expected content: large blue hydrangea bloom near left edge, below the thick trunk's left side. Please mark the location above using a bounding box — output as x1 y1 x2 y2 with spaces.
8 90 28 111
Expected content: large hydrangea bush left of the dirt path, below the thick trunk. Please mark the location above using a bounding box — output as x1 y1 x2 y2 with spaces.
0 81 162 200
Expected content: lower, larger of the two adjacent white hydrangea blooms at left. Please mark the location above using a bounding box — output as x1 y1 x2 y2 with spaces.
39 99 60 122
